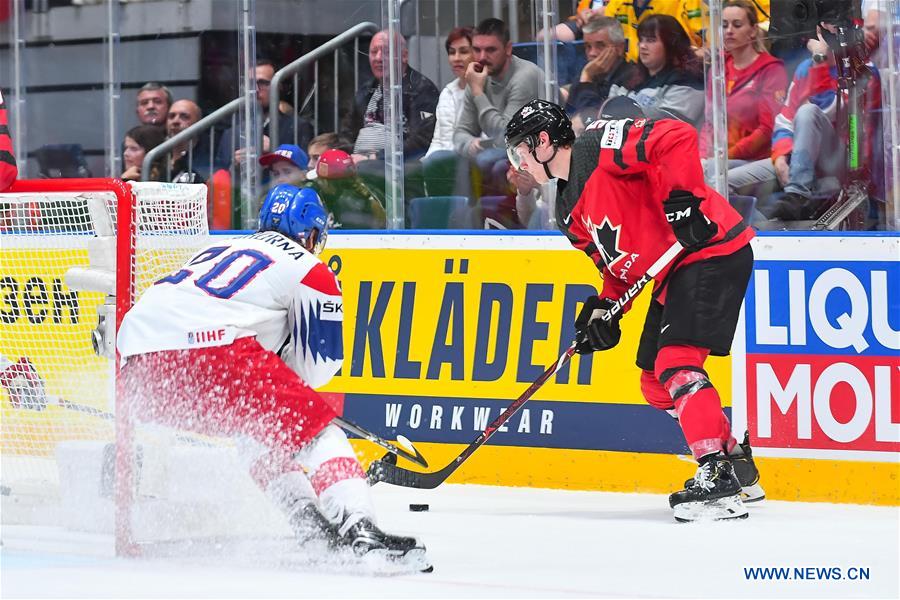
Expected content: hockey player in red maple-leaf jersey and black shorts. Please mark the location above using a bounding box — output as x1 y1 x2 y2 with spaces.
506 98 763 521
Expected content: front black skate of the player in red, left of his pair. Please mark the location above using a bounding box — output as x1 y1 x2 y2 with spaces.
669 453 747 523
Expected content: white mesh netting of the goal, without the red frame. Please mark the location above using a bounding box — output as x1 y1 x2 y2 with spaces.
0 181 209 523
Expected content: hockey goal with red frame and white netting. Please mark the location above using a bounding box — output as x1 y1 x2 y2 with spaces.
0 179 282 552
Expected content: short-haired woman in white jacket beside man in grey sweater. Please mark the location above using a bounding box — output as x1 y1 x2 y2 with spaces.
422 27 475 196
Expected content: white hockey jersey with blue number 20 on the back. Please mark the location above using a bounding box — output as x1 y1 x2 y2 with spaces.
116 231 344 388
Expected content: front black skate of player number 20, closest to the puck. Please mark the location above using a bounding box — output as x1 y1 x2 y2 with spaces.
341 517 434 573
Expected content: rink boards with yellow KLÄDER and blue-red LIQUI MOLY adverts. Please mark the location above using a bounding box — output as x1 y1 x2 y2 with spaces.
0 232 900 504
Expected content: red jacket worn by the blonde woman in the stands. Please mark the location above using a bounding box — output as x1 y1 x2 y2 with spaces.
700 52 787 160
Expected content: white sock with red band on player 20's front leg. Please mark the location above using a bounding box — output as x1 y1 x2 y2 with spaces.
296 425 375 534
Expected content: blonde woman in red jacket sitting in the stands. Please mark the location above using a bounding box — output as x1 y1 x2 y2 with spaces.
700 0 787 175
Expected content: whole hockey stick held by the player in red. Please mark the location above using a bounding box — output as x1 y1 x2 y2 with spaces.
367 242 683 490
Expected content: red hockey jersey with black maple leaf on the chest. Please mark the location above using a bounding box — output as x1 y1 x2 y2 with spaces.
557 119 753 308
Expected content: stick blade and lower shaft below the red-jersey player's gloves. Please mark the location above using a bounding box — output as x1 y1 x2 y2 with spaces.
366 344 575 490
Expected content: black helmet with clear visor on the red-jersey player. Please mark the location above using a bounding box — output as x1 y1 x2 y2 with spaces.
506 100 575 178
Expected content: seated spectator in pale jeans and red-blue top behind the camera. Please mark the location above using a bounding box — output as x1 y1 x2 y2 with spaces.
728 28 881 221
